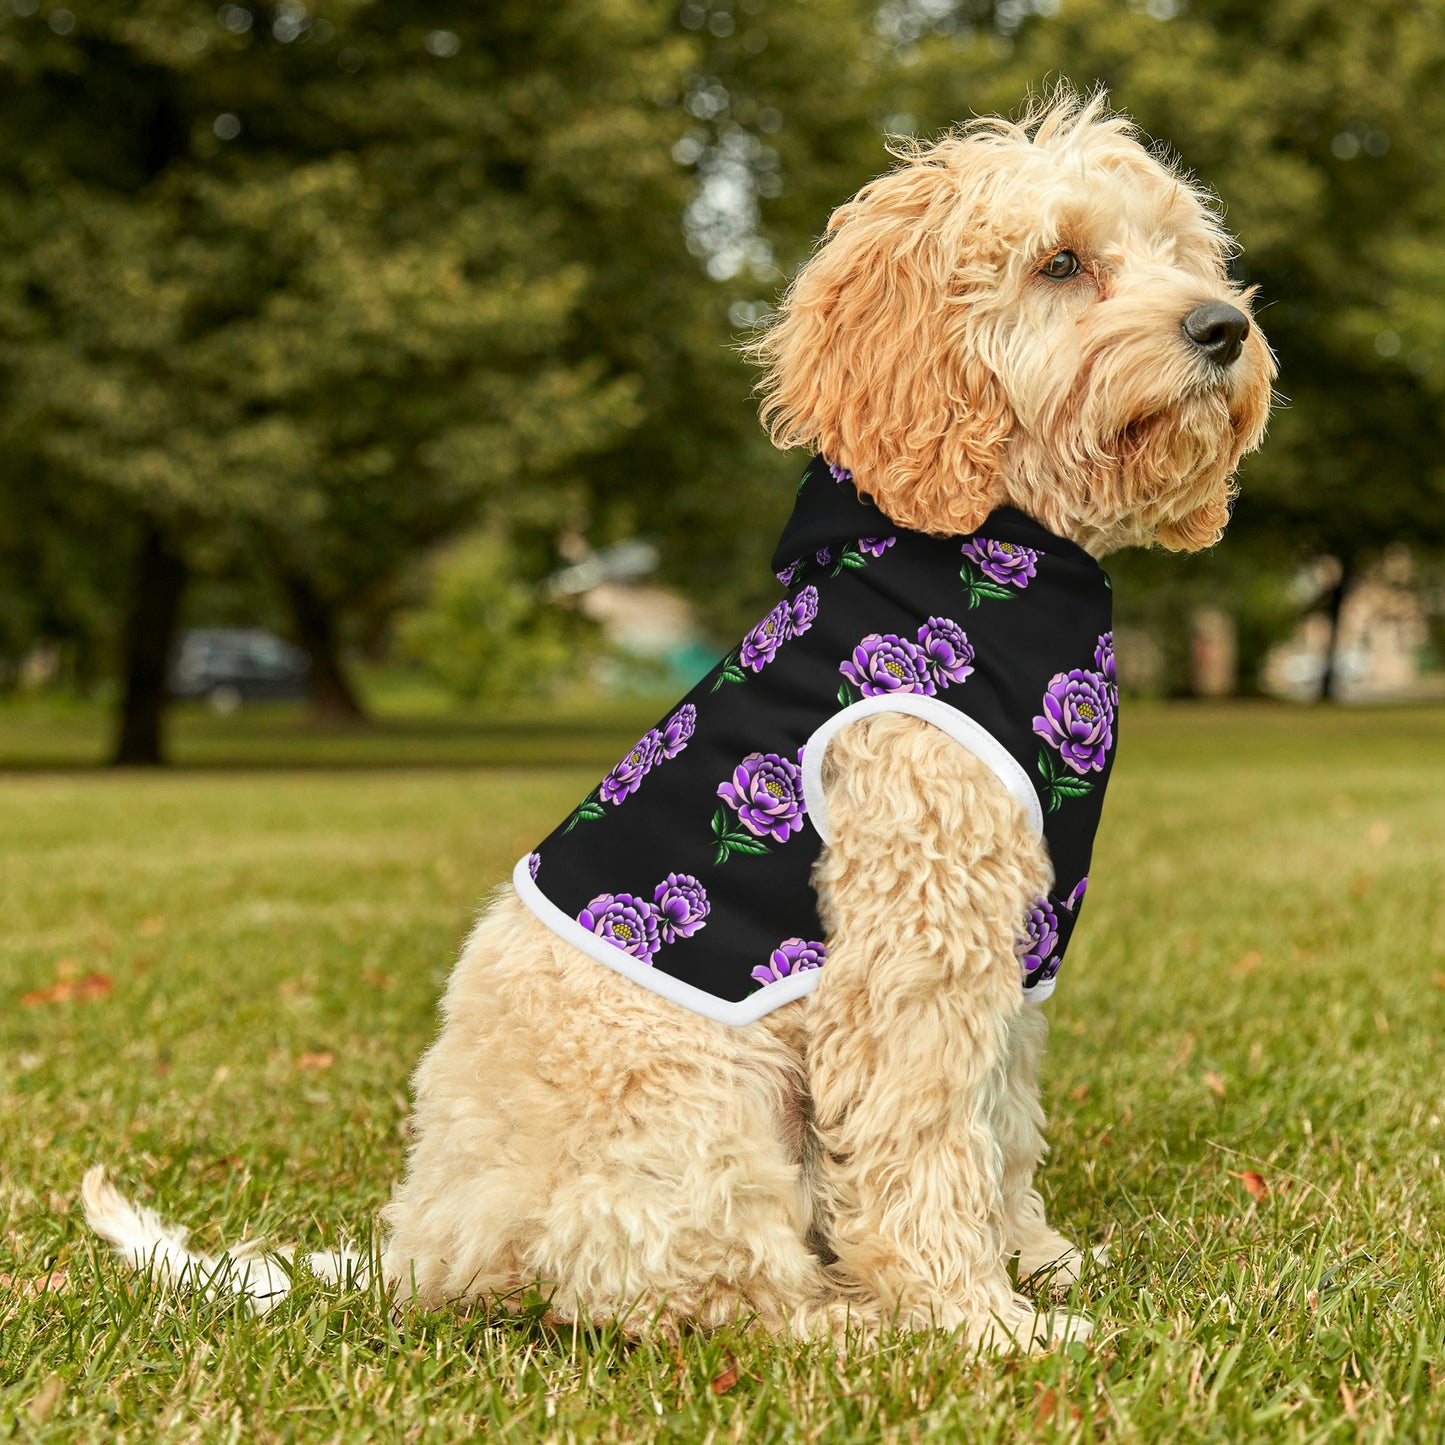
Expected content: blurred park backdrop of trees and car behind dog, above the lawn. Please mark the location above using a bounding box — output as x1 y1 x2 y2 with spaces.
0 0 1445 763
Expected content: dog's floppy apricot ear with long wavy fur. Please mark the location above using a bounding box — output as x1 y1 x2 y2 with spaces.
747 148 1013 535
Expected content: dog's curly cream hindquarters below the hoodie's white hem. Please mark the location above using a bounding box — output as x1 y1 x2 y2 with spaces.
383 890 825 1335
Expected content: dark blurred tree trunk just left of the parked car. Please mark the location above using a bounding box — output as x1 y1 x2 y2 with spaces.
111 522 186 767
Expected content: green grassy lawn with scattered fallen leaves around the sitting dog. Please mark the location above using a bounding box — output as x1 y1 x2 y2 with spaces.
0 707 1445 1442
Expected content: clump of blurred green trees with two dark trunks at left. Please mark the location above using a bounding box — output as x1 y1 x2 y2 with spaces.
0 0 691 763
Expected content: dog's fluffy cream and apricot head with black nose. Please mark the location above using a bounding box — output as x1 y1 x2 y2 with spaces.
750 91 1274 553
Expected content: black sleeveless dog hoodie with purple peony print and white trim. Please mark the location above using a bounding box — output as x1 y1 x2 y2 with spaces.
513 457 1118 1025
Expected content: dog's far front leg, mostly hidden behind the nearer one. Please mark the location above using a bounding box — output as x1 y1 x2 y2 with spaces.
993 1004 1084 1290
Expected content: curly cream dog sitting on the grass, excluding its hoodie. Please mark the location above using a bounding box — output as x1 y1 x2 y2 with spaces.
87 94 1273 1344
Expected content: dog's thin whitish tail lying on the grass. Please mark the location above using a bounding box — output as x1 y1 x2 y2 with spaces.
81 1165 370 1315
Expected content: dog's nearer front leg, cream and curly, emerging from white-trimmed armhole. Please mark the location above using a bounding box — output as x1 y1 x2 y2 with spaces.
808 714 1087 1344
